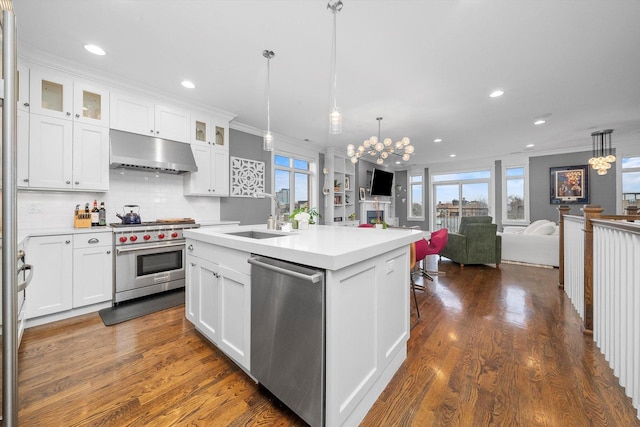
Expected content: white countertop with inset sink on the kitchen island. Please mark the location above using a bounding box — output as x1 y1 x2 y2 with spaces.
184 224 423 270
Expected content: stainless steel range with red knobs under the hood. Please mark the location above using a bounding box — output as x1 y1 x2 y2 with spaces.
109 222 200 304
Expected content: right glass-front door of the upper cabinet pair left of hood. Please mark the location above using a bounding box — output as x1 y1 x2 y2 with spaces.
73 81 109 127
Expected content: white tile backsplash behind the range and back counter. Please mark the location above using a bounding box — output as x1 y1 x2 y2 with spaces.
18 169 220 230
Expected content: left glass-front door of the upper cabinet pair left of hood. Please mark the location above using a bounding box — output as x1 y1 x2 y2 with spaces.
29 69 73 120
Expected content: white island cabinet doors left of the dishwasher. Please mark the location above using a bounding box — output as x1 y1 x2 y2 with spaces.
186 254 251 371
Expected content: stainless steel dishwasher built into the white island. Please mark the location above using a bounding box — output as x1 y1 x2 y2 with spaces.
249 255 325 426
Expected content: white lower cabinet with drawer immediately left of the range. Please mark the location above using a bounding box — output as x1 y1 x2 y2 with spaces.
73 232 113 308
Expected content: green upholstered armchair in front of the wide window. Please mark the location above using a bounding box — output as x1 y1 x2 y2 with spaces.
440 216 502 268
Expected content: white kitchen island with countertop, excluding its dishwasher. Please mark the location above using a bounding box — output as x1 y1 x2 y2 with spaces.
184 225 422 426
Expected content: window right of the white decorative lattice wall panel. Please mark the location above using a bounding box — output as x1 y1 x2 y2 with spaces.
273 154 311 218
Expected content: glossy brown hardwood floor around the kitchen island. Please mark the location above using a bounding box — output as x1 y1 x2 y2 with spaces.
19 257 640 427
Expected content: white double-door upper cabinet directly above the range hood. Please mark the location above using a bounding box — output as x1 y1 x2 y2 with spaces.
111 93 189 142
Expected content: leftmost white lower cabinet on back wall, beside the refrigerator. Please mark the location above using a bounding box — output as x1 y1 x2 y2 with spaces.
25 234 73 319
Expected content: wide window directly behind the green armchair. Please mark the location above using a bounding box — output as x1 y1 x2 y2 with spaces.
432 170 492 232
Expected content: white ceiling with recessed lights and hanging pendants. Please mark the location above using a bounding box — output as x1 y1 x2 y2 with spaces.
14 0 640 165
